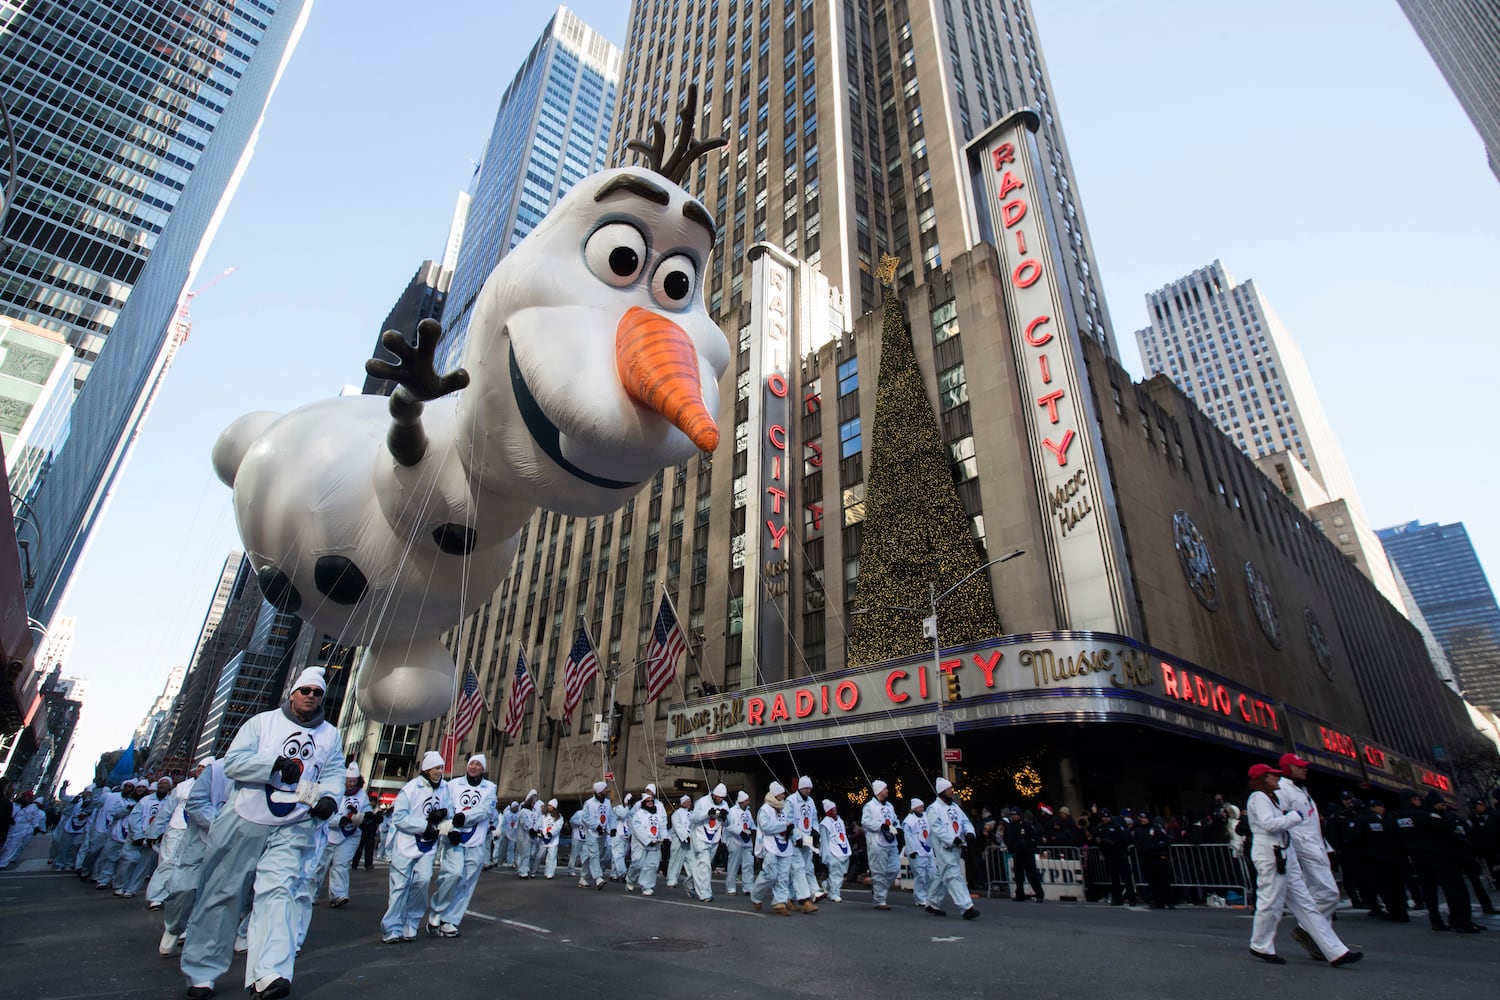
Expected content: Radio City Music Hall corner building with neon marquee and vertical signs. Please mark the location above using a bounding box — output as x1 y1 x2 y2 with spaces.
659 112 1470 810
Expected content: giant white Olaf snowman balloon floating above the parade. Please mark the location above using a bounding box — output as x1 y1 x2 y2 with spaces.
213 87 729 724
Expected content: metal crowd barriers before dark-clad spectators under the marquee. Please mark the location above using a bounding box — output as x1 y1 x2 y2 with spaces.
978 844 1256 904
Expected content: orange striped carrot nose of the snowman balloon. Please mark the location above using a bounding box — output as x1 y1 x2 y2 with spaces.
615 306 719 451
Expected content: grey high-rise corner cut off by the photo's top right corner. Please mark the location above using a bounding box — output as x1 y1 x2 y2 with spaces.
1398 0 1500 177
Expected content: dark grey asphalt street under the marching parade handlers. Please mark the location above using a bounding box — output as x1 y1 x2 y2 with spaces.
0 838 1500 1000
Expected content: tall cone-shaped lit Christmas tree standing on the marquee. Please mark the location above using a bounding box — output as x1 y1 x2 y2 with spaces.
849 256 1001 664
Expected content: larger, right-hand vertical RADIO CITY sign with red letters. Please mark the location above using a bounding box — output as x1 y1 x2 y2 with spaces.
965 109 1137 634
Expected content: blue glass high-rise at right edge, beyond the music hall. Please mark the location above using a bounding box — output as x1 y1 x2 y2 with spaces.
1377 520 1500 712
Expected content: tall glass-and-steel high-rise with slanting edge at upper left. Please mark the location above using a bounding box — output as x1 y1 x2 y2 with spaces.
0 0 312 622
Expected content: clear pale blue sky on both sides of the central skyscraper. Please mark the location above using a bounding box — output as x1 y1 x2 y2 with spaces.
52 0 1500 786
